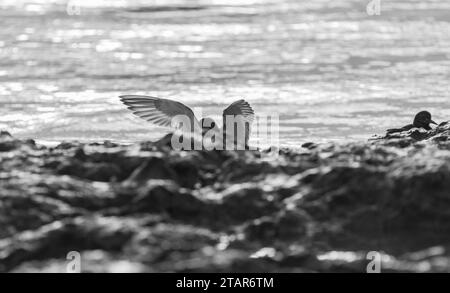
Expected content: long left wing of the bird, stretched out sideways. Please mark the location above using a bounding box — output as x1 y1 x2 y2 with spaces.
120 95 201 132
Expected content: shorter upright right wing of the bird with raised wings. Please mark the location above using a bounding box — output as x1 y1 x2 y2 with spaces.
223 100 255 148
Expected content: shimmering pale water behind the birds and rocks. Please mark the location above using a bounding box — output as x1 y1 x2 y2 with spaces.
0 0 450 146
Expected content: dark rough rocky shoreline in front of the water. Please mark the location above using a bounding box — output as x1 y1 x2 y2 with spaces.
0 122 450 273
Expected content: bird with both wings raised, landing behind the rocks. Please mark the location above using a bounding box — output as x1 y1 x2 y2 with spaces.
120 95 255 149
